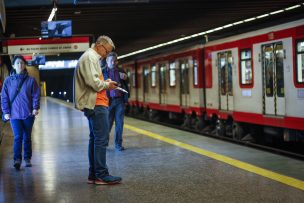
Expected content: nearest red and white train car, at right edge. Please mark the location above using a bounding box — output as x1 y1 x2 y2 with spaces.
204 20 304 141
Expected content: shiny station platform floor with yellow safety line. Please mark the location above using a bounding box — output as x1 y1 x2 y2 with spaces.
0 98 304 203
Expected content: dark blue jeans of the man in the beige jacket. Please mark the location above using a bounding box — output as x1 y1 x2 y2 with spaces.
85 106 109 178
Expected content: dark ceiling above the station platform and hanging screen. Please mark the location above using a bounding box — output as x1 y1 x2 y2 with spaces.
5 0 304 55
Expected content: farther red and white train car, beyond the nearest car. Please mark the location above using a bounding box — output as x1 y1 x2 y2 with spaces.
122 46 205 127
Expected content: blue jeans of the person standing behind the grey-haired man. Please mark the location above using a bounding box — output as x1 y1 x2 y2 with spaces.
109 97 125 149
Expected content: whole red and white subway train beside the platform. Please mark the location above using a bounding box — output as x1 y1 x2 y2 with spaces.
121 19 304 143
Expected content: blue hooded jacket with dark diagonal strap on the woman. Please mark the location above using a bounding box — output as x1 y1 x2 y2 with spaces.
1 72 40 119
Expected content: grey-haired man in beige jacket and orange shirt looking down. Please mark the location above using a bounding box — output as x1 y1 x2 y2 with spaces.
74 36 122 185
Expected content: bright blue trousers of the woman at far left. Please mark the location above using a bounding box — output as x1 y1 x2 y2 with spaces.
10 116 35 161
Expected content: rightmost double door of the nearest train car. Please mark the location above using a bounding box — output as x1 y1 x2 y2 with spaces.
262 42 285 116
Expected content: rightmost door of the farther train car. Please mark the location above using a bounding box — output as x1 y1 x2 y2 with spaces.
179 60 190 107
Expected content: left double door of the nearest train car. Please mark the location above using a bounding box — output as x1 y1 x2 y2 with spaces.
217 51 233 111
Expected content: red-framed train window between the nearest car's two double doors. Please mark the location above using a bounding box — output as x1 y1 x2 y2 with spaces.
240 49 253 85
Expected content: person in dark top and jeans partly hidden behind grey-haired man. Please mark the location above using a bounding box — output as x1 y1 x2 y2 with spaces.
106 52 128 151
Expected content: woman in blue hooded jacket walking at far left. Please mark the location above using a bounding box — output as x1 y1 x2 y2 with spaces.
1 55 40 170
